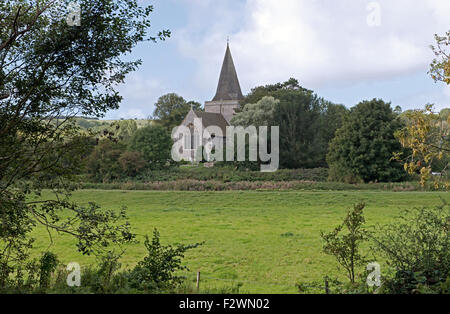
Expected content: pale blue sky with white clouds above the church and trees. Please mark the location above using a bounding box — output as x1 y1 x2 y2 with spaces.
106 0 450 119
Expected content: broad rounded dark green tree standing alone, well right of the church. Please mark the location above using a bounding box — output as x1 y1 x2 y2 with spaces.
327 99 404 182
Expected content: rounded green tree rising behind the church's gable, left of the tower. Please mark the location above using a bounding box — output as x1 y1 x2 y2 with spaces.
153 93 201 131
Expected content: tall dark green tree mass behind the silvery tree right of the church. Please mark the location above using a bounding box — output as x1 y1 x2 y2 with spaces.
237 79 341 169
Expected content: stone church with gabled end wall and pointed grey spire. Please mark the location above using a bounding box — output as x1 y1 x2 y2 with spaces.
179 43 244 161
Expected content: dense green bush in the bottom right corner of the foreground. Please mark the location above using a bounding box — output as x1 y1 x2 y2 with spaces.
373 203 450 293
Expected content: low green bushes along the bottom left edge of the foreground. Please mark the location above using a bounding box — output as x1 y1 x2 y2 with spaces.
0 229 200 294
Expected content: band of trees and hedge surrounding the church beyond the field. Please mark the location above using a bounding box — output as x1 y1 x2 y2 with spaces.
77 79 449 183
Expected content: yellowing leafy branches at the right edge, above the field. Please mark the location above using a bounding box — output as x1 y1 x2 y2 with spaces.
395 105 450 189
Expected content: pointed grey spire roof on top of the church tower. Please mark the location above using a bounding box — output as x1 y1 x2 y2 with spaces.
213 44 243 101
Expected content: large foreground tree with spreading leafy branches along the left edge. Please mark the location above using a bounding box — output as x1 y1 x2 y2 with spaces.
0 0 170 278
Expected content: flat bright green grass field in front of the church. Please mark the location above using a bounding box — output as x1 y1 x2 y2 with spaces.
29 190 450 293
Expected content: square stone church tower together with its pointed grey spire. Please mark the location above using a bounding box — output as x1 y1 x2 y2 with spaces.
205 43 244 123
